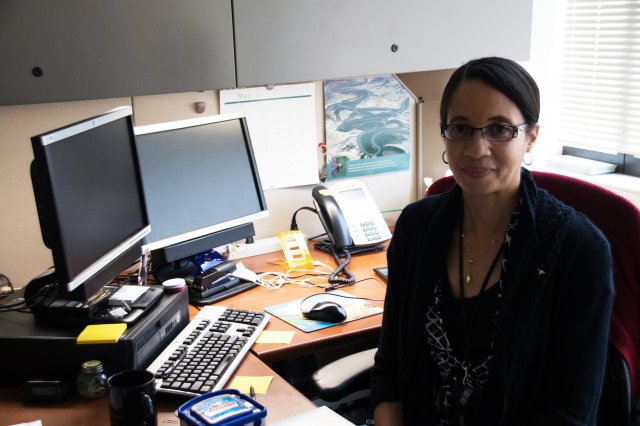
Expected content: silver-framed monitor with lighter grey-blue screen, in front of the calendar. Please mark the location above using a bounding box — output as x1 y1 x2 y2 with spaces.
134 113 268 281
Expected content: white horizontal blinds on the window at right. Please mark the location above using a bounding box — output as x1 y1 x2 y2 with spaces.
559 0 640 155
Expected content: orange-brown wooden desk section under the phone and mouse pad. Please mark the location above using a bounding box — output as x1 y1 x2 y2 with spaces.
190 244 387 363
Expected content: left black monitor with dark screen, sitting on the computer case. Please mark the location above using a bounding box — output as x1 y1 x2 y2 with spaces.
31 107 150 301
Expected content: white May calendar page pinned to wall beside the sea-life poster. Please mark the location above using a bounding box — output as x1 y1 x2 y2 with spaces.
220 83 319 190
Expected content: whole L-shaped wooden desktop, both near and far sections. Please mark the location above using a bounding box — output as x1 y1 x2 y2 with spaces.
0 243 386 426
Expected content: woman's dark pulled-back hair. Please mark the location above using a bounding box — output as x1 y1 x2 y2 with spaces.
440 57 540 127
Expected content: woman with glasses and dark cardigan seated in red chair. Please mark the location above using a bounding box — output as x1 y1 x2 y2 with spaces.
372 58 613 426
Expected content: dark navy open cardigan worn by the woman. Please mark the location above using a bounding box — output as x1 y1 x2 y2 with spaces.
371 169 614 425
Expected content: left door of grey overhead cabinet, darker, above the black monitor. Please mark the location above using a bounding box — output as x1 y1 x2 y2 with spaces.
0 0 235 105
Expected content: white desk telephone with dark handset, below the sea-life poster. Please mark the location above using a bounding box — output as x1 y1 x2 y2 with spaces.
311 180 391 251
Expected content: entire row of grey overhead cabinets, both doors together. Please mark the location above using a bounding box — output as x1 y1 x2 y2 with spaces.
0 0 533 105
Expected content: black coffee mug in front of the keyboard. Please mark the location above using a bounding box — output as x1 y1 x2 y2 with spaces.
109 370 158 426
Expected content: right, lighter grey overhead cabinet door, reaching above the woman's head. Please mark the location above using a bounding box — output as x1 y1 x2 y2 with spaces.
233 0 532 86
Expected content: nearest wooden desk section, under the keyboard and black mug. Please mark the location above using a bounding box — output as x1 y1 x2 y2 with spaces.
0 353 315 426
